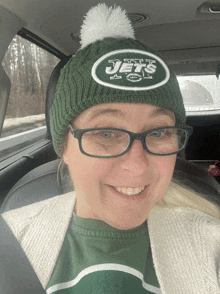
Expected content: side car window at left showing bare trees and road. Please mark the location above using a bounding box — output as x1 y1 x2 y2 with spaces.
0 35 60 156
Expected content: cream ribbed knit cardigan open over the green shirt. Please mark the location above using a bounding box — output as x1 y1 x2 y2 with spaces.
3 192 220 294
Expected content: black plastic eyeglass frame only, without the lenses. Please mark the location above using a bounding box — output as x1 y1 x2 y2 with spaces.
68 124 193 158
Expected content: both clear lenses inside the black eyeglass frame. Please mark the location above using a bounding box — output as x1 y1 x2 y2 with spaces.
81 128 187 156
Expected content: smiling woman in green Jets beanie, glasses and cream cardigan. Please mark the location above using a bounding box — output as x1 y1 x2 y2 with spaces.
3 4 220 294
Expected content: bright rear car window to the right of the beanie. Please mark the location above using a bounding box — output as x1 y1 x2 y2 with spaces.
178 75 220 116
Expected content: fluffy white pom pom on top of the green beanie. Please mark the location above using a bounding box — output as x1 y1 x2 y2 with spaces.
80 3 135 49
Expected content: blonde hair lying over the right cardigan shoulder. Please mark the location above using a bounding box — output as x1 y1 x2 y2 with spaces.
157 181 220 219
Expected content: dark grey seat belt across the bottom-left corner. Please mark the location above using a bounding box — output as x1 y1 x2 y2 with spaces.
0 215 46 294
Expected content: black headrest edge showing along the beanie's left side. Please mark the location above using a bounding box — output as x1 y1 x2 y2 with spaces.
45 56 71 140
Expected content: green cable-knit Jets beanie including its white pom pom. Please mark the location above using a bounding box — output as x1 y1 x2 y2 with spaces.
50 4 186 156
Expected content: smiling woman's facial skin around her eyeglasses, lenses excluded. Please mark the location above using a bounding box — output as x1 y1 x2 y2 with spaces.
63 103 176 230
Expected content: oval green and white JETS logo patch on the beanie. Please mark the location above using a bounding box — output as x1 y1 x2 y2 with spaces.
92 49 170 91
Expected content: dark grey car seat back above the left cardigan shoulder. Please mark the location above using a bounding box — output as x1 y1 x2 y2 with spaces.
0 159 74 213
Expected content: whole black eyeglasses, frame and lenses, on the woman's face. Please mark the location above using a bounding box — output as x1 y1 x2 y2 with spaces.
68 125 193 158
